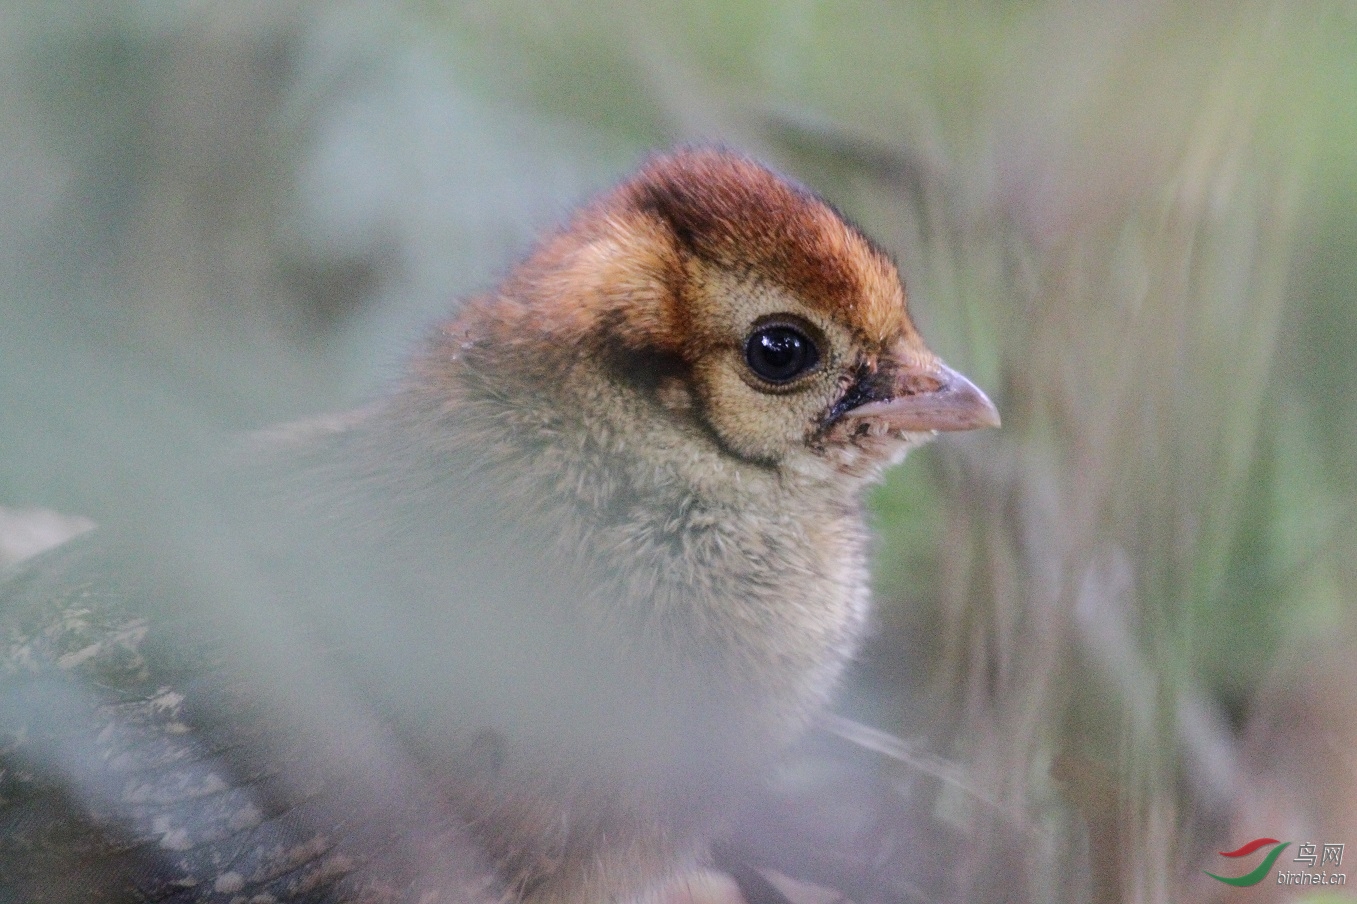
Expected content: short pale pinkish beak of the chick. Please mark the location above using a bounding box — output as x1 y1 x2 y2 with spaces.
843 360 999 433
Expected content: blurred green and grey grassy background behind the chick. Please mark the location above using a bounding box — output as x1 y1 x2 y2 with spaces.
0 0 1357 901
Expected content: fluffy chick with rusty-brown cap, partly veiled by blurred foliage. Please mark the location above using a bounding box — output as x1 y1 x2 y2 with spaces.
0 149 999 904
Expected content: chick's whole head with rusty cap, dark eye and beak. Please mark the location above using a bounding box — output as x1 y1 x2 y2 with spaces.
450 149 999 476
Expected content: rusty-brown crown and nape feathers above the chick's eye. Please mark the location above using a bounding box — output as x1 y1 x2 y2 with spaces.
472 148 917 352
